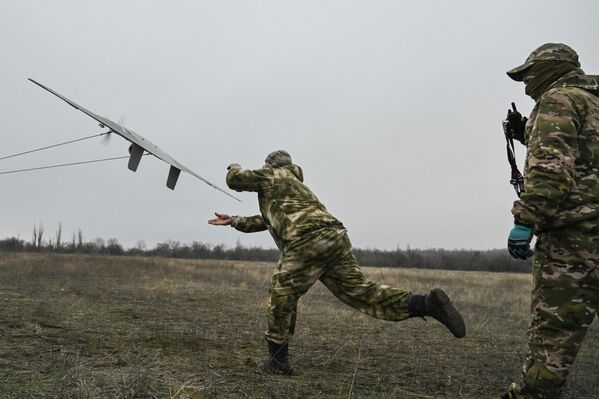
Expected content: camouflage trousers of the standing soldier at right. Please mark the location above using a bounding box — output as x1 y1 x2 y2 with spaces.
509 221 599 399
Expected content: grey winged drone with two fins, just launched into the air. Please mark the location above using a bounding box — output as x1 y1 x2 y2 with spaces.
29 79 241 201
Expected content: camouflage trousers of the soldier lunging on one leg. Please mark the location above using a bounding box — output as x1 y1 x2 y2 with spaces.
266 229 411 344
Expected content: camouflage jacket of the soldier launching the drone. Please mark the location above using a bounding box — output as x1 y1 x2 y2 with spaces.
227 165 344 250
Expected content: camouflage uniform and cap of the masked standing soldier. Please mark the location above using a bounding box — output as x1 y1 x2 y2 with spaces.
508 43 599 399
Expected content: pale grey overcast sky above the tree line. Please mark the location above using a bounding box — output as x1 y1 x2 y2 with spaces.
0 0 599 249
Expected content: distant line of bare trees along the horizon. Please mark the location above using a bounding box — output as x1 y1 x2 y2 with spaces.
0 223 531 272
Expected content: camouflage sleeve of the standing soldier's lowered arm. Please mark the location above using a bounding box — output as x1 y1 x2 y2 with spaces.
512 91 580 228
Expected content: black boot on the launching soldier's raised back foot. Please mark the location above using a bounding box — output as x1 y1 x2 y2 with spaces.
408 288 466 338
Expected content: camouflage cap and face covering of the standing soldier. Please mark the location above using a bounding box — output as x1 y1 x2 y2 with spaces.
507 43 583 101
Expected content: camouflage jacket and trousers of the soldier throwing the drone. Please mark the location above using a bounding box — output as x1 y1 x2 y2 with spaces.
227 159 411 344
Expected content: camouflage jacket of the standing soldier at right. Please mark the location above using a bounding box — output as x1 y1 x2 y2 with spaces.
512 70 599 231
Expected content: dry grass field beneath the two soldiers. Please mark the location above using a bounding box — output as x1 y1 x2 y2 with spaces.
0 253 599 399
